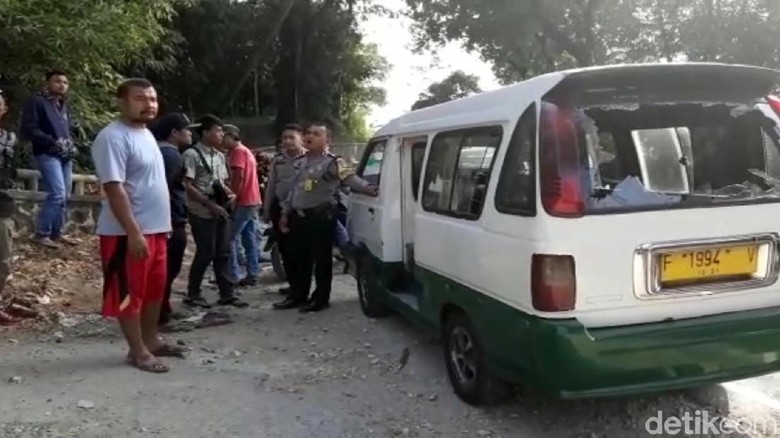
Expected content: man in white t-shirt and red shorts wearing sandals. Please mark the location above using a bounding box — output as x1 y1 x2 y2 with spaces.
92 79 183 373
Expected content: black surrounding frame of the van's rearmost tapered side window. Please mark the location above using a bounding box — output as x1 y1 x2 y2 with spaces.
493 101 539 217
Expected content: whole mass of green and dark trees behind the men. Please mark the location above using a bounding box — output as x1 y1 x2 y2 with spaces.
0 0 388 159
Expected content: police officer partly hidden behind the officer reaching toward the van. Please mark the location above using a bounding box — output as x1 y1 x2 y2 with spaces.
263 124 306 294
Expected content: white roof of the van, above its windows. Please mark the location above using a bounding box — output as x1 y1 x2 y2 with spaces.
375 62 780 137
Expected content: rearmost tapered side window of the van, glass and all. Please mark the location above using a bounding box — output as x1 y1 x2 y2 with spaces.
495 104 536 216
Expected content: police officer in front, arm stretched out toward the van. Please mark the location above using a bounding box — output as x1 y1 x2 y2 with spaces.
274 123 378 313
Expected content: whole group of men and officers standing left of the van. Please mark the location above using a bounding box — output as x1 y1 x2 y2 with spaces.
0 72 377 373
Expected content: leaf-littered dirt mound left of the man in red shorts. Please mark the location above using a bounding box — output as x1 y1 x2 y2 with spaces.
0 234 102 329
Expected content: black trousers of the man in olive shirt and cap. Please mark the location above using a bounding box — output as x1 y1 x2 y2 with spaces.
187 215 234 300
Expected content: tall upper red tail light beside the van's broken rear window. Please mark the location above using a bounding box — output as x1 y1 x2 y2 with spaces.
539 103 587 217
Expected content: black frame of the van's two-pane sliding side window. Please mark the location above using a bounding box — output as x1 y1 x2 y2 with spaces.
418 124 504 222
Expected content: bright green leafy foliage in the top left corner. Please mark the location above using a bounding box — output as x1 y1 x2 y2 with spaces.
0 0 189 132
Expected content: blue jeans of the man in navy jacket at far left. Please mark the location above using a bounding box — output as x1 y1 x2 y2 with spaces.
35 154 73 240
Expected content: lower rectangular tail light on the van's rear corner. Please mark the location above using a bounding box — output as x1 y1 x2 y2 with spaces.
531 254 577 312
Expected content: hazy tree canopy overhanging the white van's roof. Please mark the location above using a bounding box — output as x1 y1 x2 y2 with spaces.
406 0 780 83
